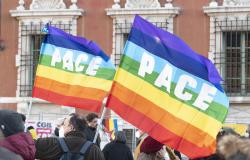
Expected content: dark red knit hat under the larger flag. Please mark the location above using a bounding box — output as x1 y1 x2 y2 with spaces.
140 136 163 154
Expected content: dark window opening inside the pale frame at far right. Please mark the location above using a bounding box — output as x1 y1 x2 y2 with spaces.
224 31 250 95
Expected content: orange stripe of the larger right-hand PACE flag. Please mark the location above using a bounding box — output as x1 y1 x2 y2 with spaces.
112 82 215 147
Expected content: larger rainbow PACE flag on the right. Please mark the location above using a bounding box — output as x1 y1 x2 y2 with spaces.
107 16 229 158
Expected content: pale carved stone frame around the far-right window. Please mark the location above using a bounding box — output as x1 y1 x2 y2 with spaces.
203 0 250 104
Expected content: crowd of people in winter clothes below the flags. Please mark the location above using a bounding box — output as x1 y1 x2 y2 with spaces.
0 110 250 160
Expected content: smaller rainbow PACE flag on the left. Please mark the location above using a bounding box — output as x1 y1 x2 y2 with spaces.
33 26 115 112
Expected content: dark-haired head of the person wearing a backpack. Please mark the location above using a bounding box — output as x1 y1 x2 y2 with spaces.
62 113 86 135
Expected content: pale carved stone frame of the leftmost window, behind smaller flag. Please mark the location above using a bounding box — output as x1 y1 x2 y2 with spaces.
9 0 84 116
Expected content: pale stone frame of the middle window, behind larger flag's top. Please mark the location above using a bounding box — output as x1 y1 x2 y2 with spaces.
106 0 180 67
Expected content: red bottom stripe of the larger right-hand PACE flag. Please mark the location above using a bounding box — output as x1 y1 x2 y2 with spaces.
108 95 215 158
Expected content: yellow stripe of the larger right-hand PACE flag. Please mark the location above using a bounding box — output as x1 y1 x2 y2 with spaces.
115 68 222 138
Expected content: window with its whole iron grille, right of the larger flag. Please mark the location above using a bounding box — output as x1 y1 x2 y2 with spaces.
215 19 250 97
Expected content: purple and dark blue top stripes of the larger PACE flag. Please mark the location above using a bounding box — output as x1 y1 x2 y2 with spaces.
130 16 222 84
